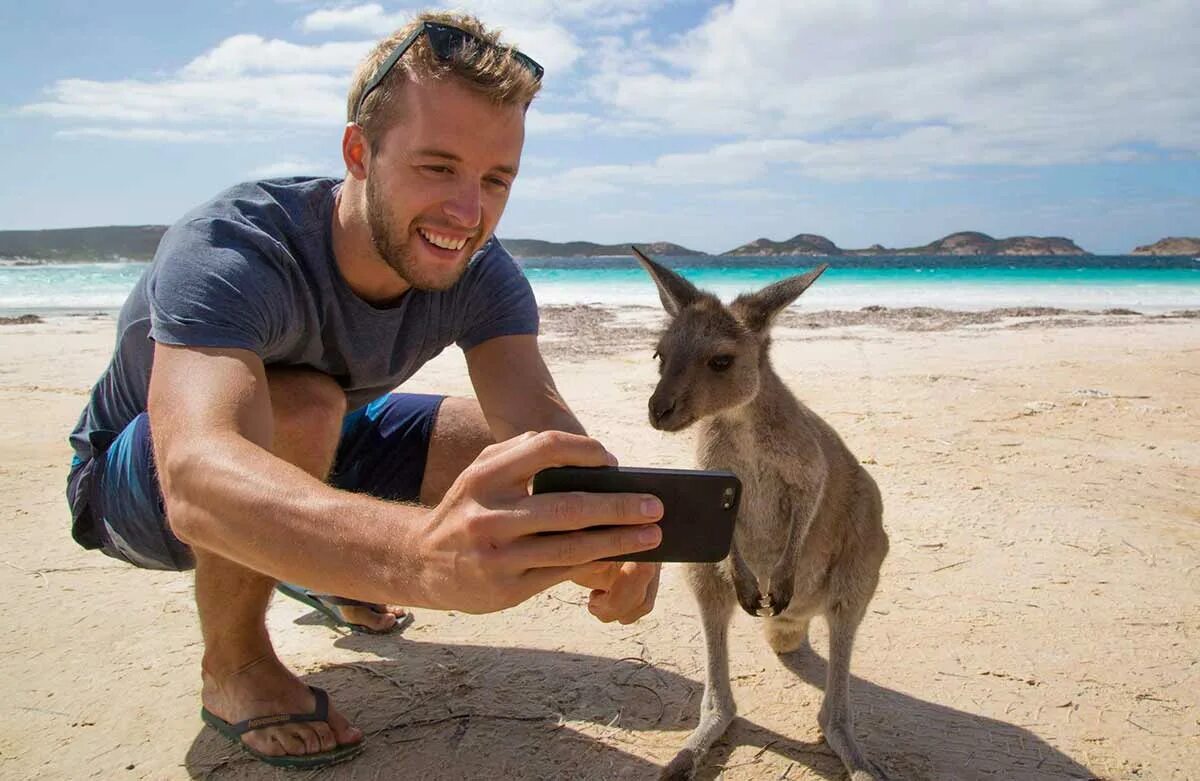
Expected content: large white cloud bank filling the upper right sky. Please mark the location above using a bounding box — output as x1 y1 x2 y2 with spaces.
593 0 1200 163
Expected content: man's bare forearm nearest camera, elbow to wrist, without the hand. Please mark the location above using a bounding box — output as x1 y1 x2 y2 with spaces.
162 433 427 606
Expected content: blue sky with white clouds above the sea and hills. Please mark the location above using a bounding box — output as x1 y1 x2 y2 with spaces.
0 0 1200 253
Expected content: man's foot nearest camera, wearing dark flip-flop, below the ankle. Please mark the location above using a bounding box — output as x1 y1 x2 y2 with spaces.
200 655 362 757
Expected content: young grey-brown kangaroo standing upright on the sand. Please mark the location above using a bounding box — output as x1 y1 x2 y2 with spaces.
634 247 888 781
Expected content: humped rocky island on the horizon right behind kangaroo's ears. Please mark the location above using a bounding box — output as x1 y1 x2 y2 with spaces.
721 230 1091 257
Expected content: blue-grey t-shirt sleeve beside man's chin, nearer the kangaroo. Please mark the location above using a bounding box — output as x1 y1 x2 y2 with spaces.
455 239 538 350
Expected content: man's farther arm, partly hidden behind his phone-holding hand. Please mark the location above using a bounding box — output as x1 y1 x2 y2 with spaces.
467 335 661 624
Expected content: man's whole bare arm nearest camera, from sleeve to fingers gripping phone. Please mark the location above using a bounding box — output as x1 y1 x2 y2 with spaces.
149 343 661 612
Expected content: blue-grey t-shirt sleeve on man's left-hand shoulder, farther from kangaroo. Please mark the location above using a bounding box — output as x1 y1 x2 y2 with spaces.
146 213 295 358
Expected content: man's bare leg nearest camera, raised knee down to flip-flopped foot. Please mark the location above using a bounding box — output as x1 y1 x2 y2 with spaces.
193 371 360 756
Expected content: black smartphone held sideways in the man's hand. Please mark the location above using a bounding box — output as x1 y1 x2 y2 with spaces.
533 467 742 561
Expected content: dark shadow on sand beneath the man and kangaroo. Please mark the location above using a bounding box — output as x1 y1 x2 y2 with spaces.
186 635 1096 781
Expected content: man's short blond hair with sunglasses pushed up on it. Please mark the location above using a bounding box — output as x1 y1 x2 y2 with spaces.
346 12 541 144
